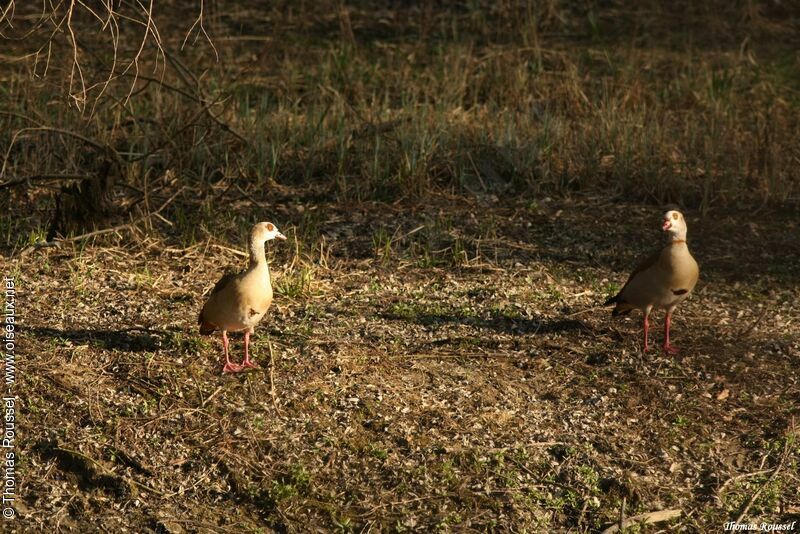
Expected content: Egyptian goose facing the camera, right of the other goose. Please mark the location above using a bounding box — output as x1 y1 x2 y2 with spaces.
605 210 700 354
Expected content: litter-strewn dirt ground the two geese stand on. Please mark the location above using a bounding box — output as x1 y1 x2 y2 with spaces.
3 190 800 533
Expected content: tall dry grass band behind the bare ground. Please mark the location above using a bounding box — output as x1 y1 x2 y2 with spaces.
0 2 800 235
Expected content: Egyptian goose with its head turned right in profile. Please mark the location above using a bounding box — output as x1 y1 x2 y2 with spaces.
197 222 286 373
